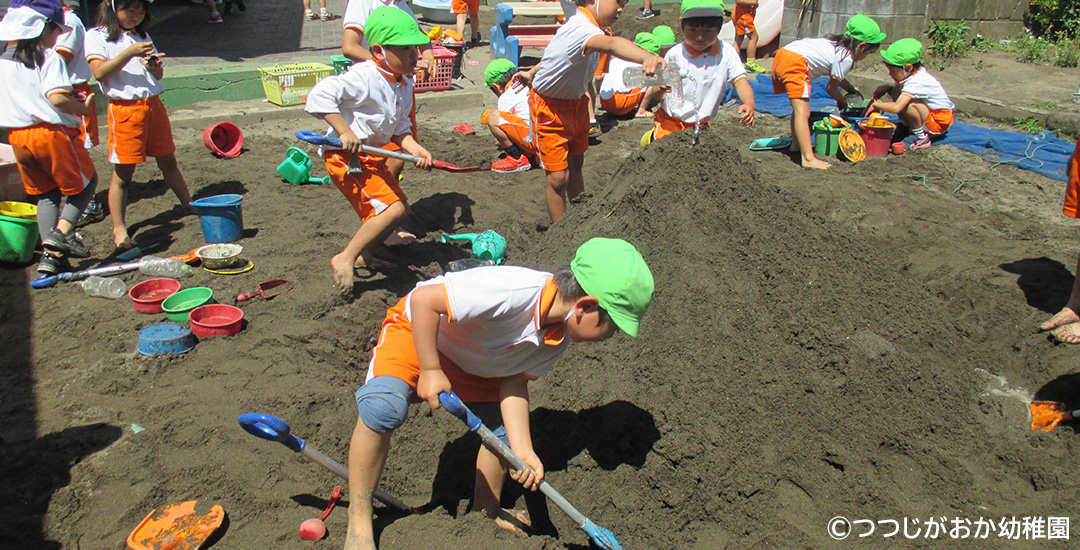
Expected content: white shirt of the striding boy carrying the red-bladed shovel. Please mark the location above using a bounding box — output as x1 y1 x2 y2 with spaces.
303 59 413 147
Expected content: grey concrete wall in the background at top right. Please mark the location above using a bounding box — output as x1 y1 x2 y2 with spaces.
780 0 1028 44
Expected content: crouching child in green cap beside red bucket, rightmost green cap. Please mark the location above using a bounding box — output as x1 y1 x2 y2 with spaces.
866 38 955 149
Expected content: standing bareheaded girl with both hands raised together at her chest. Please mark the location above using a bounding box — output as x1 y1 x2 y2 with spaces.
86 0 195 252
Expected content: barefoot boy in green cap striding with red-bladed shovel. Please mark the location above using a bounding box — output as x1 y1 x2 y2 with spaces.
305 5 431 293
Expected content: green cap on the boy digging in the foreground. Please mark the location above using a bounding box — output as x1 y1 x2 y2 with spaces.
570 238 652 336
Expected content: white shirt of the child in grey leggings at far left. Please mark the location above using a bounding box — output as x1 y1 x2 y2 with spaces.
0 48 82 129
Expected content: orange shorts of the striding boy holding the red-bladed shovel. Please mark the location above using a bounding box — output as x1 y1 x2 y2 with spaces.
323 149 408 222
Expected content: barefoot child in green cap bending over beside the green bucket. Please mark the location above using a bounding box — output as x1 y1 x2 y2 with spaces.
772 15 886 170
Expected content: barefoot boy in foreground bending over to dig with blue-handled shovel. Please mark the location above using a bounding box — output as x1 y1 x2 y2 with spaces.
345 239 653 550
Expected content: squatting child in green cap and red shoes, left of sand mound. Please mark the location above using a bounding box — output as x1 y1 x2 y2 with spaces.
480 58 537 174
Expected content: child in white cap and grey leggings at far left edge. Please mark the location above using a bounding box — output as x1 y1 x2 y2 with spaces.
0 0 97 274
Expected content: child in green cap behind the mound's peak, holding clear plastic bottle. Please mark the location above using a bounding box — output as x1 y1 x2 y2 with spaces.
645 0 754 142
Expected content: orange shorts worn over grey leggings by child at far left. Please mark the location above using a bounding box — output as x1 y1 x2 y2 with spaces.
8 124 96 197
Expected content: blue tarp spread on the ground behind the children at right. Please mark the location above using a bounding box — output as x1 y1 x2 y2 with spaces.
750 77 1075 182
